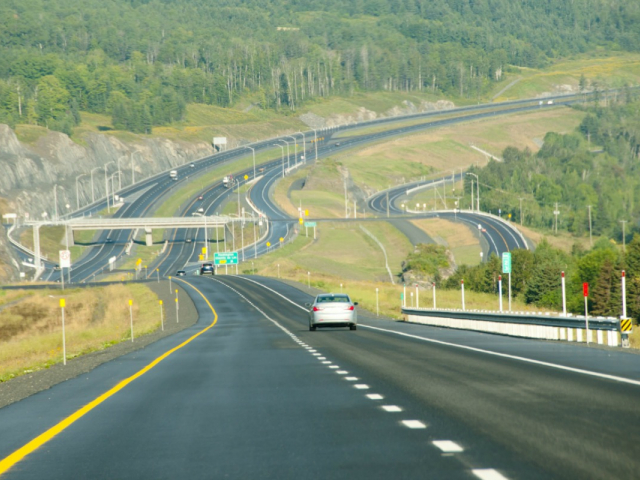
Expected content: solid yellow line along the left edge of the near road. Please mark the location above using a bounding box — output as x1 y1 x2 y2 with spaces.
0 278 218 475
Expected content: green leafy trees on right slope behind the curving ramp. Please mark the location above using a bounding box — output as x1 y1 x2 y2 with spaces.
465 95 640 243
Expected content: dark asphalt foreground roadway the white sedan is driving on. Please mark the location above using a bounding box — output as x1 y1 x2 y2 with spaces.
0 276 640 479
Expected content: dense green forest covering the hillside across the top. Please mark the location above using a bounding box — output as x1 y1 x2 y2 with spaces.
0 0 640 132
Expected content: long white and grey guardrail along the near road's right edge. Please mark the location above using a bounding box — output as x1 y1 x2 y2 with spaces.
402 307 621 347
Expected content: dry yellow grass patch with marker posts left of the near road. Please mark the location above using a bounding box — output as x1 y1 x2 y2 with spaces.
0 284 160 382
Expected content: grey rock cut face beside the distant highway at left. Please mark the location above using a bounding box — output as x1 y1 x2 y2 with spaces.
0 124 213 281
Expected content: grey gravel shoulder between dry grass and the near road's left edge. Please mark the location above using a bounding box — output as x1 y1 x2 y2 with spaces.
0 281 198 408
